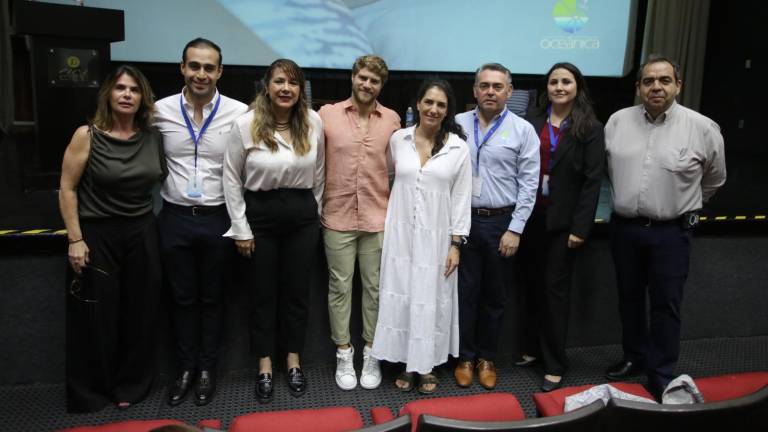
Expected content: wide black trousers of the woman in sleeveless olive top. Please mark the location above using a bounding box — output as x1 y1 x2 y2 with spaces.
66 213 161 412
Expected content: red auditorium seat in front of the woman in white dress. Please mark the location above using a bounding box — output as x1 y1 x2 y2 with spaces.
371 392 525 432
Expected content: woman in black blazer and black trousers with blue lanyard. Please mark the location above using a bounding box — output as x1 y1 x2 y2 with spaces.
517 63 605 391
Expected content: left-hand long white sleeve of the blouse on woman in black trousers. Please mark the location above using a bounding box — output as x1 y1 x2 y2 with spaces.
222 122 253 240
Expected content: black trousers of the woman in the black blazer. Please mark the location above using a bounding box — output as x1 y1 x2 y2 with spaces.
517 209 579 376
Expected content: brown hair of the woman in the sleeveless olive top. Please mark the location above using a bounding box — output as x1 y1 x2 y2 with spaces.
91 65 155 131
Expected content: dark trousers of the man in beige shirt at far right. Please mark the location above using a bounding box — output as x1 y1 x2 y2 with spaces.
611 216 691 394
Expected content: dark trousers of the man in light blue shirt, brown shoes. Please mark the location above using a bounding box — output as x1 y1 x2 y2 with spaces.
459 214 513 360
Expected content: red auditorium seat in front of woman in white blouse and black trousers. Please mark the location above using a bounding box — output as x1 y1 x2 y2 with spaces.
229 407 363 432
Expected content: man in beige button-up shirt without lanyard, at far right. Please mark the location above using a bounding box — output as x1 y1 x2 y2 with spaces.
605 56 726 400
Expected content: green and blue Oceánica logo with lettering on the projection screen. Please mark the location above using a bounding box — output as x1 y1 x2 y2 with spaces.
539 0 600 50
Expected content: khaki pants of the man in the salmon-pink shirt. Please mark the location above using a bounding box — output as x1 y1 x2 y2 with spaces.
323 228 384 345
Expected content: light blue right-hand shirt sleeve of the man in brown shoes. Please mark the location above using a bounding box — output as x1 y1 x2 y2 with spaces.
509 126 541 234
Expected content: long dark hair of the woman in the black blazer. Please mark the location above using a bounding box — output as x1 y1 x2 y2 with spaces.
537 62 597 139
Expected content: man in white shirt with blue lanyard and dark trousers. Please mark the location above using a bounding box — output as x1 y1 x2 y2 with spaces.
155 38 248 406
